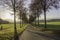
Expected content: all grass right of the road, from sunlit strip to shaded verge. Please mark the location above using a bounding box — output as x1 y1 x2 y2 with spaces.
34 22 60 37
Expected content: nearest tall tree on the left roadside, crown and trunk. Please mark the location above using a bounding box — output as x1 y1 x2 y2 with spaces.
1 0 24 40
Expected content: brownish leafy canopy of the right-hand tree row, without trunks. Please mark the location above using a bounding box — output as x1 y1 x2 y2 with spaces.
29 0 60 21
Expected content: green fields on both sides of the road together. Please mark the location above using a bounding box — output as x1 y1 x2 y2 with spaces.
0 22 60 40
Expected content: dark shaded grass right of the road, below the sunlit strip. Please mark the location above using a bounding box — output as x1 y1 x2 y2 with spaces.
33 24 60 37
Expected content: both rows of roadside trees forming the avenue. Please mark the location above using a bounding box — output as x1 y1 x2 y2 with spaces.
0 0 60 40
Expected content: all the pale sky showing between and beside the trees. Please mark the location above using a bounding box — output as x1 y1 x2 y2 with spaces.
0 0 60 21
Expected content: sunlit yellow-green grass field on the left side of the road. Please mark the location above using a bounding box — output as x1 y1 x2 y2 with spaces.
0 24 27 40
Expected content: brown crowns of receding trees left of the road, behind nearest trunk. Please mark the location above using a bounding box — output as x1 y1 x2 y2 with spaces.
17 0 28 23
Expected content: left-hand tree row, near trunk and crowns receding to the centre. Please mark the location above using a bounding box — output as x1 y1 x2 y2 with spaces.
1 0 28 40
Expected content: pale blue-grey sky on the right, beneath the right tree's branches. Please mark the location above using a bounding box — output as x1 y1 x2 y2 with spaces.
40 8 60 20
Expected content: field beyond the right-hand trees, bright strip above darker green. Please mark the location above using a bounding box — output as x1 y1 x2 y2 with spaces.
35 22 60 30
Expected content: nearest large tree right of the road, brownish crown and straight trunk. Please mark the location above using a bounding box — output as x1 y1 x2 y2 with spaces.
31 0 60 28
